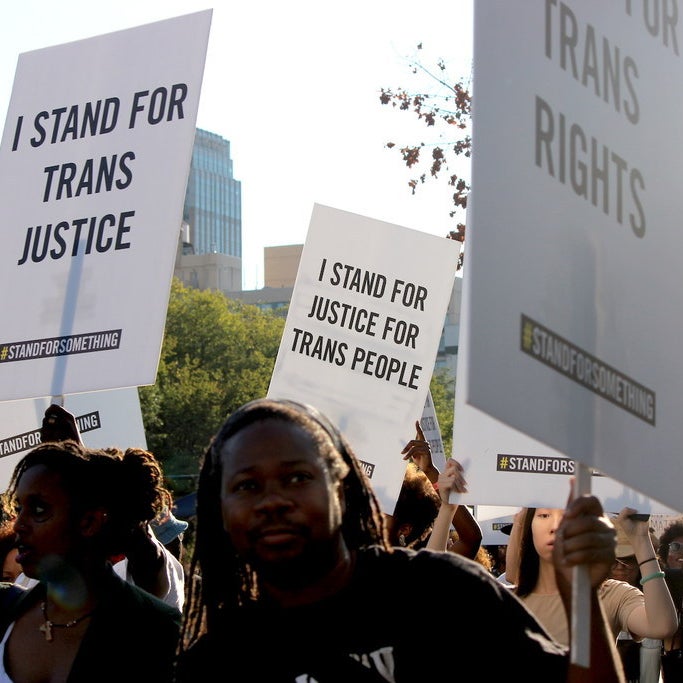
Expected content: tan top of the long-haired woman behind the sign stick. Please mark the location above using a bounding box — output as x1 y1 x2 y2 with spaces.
521 579 645 647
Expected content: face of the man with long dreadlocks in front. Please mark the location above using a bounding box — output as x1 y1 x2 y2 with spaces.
220 419 343 584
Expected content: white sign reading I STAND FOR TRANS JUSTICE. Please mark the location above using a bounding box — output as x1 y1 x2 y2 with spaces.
0 10 212 401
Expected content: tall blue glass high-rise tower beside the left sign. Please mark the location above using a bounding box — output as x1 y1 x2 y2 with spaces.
183 128 242 259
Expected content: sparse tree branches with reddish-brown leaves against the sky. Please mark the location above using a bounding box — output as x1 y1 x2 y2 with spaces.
380 43 472 269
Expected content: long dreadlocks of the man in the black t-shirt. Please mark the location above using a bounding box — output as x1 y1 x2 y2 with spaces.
179 398 390 652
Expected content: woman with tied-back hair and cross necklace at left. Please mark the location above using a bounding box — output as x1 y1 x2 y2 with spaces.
0 440 181 683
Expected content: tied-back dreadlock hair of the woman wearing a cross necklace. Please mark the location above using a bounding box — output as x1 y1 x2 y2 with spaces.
2 440 172 557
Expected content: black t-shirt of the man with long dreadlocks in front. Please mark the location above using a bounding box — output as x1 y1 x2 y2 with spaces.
177 548 568 683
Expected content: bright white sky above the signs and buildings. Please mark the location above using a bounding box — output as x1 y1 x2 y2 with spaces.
0 0 473 289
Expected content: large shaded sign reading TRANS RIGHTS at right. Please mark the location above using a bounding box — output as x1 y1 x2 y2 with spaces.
465 0 683 506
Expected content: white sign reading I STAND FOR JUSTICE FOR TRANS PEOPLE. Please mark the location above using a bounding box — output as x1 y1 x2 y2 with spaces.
268 204 460 513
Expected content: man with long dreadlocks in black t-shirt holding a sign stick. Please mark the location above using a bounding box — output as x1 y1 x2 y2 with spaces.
176 398 623 683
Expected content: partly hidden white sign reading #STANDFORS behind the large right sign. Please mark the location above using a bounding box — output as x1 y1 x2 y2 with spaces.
452 265 683 514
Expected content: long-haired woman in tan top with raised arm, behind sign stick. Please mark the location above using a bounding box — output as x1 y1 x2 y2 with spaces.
506 508 677 656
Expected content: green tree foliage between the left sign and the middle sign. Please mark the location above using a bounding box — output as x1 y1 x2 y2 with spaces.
138 278 285 494
